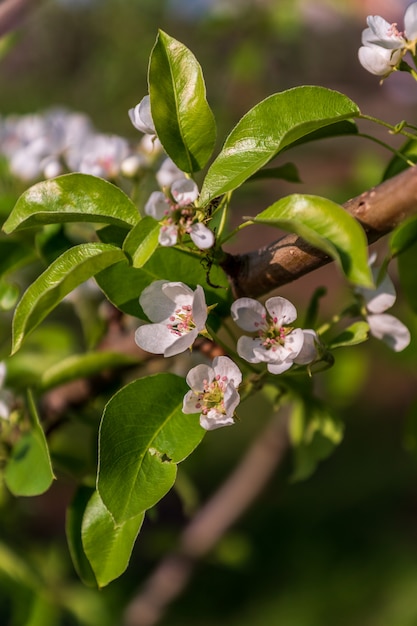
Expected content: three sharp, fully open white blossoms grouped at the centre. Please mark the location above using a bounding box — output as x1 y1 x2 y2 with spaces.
135 280 318 430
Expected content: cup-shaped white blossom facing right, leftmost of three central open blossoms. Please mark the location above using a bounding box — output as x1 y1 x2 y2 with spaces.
135 280 207 357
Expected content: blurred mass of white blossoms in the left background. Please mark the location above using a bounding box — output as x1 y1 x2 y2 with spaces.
0 109 160 182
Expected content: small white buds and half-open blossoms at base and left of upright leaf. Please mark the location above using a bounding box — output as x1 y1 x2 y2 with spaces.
129 96 214 250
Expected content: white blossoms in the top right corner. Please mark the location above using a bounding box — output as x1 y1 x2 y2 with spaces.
358 2 417 78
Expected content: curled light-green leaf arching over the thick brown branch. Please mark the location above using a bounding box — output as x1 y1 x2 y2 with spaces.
254 194 374 287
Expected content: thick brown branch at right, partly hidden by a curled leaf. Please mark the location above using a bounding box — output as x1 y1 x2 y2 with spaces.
222 167 417 297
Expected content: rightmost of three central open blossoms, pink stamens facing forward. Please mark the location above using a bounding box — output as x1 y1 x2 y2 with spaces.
231 296 304 374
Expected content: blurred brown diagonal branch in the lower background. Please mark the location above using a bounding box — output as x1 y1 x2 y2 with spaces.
125 407 289 626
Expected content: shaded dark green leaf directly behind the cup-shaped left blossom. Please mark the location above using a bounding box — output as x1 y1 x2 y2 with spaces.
96 246 231 319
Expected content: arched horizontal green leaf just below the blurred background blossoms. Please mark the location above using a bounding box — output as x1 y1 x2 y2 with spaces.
3 174 140 233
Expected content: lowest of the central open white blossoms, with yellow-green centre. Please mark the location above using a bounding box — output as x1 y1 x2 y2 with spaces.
182 356 242 430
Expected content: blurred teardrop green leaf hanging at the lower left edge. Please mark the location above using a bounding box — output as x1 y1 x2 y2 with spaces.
4 394 54 496
